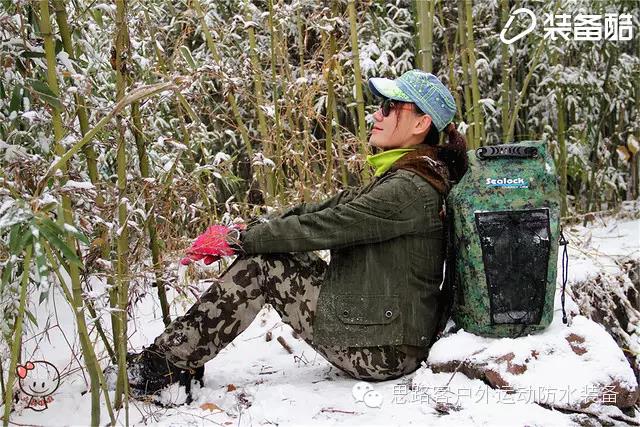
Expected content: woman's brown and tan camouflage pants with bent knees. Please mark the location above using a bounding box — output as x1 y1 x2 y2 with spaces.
155 252 426 381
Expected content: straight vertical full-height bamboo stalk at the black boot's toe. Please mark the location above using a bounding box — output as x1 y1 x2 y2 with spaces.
115 0 129 425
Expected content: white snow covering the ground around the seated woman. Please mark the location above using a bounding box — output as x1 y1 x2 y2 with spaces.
11 220 640 426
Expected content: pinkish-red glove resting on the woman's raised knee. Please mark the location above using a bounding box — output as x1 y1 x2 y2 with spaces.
180 224 246 265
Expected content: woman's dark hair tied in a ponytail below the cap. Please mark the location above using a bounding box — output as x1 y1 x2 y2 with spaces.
413 104 469 182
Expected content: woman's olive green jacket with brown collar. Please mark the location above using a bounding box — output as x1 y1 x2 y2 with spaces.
240 145 448 347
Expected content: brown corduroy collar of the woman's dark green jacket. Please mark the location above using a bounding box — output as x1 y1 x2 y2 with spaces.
390 144 451 195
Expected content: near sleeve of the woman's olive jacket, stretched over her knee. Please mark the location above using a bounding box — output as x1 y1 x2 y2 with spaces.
240 176 420 254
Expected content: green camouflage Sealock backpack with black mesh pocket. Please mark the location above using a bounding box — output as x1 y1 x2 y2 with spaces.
444 141 560 337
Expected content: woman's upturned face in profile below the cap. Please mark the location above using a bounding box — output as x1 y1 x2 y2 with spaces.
369 101 431 150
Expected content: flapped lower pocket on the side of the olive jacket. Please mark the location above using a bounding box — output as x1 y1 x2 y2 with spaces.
334 295 400 325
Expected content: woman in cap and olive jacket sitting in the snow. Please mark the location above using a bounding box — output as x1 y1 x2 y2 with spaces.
110 70 467 393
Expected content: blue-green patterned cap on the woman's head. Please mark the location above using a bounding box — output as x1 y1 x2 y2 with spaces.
369 70 456 132
